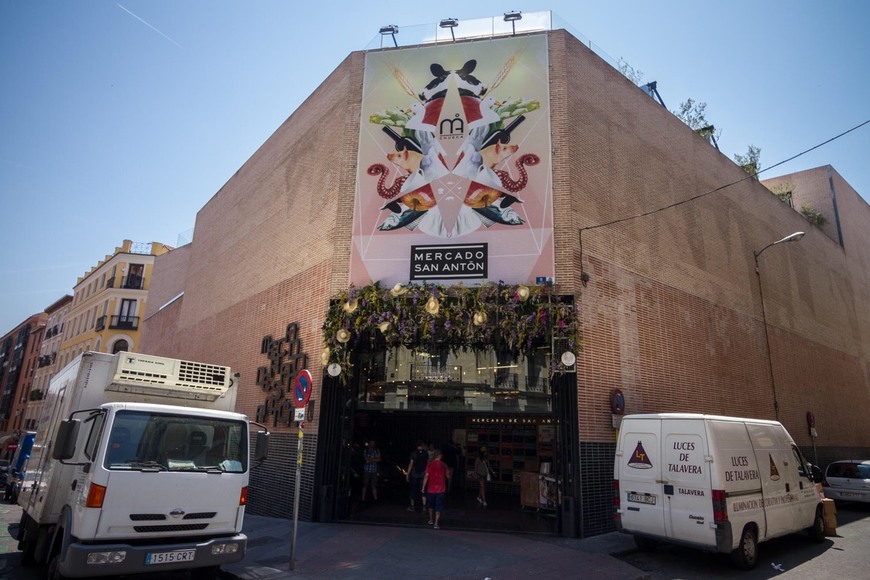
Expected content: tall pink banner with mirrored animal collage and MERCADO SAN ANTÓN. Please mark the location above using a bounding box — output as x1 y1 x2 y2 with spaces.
350 35 555 286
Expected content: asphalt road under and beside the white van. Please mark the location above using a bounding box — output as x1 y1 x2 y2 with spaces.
619 503 870 580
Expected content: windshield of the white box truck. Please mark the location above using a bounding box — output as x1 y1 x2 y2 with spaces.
103 411 248 473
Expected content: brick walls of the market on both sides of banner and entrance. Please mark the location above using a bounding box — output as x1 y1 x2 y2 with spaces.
143 31 870 535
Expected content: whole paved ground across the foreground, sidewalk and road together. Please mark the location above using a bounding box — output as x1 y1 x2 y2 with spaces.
0 494 870 580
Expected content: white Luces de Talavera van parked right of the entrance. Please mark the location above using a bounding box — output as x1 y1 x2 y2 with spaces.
614 413 825 569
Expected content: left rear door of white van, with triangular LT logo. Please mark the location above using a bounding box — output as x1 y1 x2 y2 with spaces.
616 419 665 537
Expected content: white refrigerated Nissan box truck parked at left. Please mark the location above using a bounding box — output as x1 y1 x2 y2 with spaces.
17 352 269 578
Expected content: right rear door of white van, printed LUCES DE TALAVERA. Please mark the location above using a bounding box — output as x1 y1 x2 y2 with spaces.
662 419 716 546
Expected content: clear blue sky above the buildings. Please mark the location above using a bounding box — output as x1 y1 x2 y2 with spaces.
0 0 870 335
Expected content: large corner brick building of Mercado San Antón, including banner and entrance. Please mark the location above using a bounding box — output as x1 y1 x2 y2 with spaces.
140 22 870 536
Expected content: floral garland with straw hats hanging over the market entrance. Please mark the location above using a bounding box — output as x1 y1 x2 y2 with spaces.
320 282 579 380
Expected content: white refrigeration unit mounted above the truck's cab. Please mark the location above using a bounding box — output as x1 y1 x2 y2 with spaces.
107 352 233 401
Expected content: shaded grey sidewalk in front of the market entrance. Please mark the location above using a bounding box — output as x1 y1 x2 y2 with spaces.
222 516 646 580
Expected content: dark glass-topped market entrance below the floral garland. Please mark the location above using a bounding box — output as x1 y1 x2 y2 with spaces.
318 348 576 534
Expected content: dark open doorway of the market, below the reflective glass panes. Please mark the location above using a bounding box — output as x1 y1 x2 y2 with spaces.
344 411 558 534
